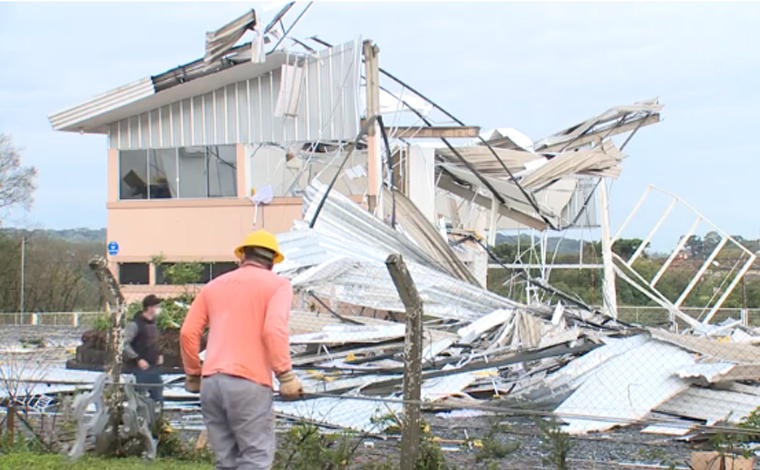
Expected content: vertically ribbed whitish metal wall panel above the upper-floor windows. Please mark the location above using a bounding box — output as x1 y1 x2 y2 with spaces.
110 41 361 149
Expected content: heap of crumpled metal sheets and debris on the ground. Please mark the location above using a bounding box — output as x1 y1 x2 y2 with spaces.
260 182 760 435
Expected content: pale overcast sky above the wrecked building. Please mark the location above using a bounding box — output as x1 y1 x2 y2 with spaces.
0 2 760 250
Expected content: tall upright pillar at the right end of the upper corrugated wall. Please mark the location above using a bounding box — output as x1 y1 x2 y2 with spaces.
364 40 383 220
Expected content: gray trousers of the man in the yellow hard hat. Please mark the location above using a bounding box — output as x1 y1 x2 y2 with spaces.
201 374 275 470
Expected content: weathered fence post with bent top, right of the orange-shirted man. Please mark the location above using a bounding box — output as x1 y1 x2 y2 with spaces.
385 254 423 470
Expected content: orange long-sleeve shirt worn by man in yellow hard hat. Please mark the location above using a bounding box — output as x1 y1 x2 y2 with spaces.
180 266 293 387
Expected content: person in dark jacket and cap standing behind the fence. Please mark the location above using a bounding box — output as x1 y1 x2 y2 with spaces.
124 295 164 404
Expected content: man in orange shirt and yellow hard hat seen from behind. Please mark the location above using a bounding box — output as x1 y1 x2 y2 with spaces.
180 230 303 470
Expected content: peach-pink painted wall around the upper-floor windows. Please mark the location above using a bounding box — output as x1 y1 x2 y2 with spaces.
107 144 303 301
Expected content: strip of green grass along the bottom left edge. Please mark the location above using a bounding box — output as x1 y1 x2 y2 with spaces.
0 453 214 470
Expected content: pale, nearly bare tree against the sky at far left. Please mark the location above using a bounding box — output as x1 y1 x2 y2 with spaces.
0 134 37 218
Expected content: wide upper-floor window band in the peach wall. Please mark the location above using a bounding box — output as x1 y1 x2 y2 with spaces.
119 145 237 200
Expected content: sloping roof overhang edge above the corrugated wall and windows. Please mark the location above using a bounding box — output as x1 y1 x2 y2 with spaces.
48 51 293 134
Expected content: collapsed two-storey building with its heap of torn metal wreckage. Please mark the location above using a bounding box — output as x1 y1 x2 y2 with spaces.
38 5 760 454
